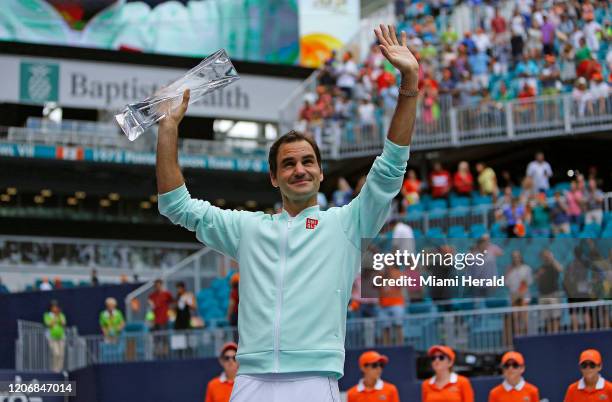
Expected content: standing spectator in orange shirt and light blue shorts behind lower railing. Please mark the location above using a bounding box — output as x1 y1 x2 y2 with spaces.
378 267 405 345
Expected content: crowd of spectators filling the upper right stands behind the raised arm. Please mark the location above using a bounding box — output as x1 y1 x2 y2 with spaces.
299 0 612 142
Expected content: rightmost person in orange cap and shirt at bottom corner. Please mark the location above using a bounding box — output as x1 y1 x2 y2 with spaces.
563 349 612 402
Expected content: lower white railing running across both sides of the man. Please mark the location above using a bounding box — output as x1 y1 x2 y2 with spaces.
16 299 612 370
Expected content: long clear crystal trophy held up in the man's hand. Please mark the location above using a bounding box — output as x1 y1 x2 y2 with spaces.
115 49 240 141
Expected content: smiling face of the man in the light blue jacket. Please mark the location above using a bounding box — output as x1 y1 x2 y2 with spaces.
270 141 323 201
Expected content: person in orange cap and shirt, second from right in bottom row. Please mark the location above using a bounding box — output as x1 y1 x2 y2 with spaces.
489 352 540 402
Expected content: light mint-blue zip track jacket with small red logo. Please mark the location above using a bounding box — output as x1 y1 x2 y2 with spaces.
158 140 410 378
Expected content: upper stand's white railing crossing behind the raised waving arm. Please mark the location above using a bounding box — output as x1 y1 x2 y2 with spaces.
310 95 612 159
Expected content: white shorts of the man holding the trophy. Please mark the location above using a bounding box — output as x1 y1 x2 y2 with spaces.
230 373 340 402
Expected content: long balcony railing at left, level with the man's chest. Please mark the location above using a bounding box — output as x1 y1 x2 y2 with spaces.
0 236 202 272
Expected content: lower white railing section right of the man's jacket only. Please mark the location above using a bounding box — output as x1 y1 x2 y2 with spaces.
346 300 612 353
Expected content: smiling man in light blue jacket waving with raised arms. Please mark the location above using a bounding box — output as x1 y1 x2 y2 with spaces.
157 25 419 402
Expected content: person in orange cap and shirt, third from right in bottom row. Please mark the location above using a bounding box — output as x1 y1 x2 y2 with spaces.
421 345 474 402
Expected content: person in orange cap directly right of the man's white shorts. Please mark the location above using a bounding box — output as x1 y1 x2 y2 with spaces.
346 350 399 402
